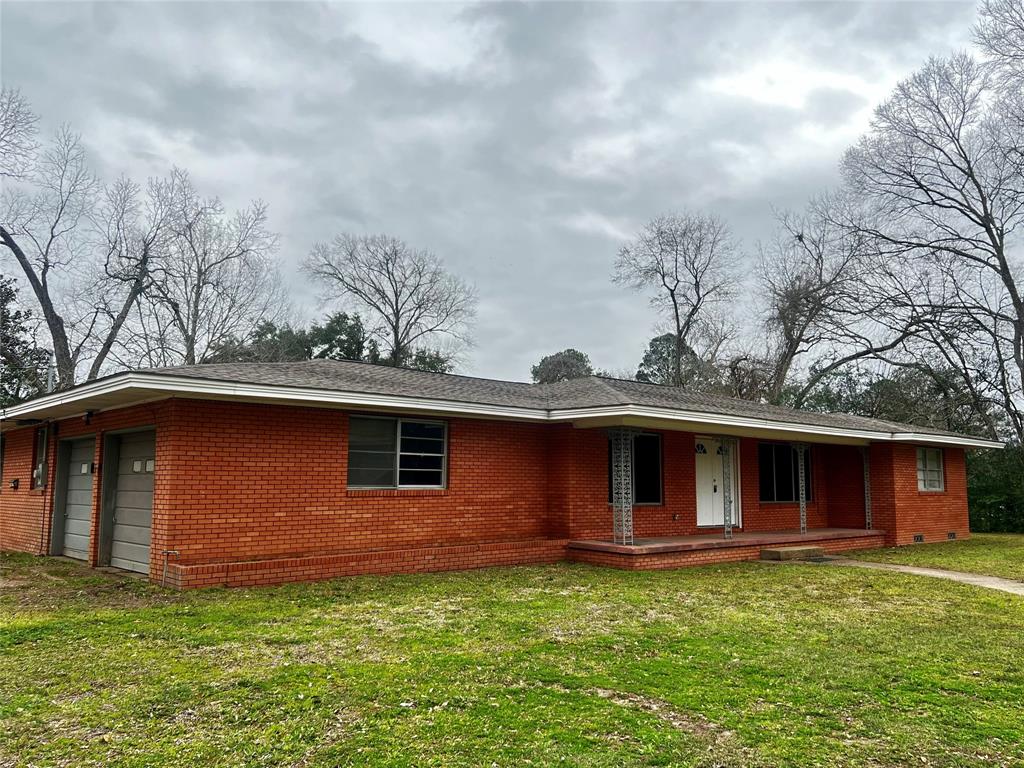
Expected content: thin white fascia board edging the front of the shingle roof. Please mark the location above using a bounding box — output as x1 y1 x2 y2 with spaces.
0 373 1002 447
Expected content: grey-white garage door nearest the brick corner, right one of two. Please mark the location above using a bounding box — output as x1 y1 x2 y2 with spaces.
111 432 157 573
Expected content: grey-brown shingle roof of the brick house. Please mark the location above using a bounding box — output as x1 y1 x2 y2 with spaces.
140 360 974 442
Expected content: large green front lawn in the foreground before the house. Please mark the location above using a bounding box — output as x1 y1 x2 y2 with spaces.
0 555 1024 767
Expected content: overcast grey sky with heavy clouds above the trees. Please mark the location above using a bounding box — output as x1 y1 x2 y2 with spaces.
0 0 974 379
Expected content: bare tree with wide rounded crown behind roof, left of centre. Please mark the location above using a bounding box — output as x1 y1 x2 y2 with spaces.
305 234 476 366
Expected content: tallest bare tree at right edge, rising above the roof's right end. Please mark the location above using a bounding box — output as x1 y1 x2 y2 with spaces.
844 54 1024 440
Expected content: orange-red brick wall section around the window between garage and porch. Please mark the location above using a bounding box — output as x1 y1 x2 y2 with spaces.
162 400 553 564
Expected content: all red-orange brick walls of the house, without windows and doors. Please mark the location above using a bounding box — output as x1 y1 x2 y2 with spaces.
0 398 968 586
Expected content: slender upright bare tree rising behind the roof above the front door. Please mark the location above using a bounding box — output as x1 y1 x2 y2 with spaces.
613 213 738 386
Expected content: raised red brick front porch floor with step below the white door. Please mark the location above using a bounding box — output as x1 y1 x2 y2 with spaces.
567 528 886 570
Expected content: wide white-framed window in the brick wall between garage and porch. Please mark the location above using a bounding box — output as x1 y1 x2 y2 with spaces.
348 416 447 488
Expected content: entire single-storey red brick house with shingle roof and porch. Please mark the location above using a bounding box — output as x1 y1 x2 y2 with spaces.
0 360 998 587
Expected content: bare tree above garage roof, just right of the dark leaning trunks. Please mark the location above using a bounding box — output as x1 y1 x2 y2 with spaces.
120 169 286 366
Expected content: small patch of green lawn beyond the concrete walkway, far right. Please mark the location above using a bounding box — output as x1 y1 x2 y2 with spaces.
850 534 1024 582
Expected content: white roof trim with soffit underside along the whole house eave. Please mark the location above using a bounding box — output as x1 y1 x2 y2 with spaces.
0 372 1002 447
